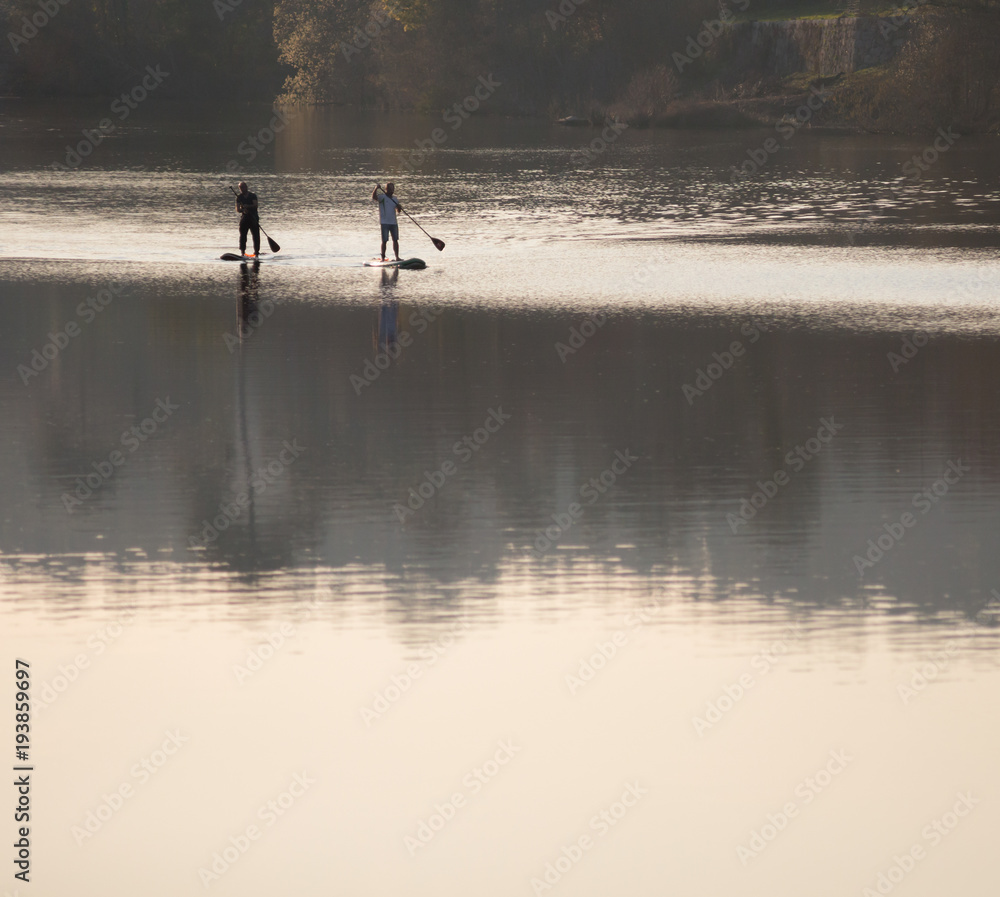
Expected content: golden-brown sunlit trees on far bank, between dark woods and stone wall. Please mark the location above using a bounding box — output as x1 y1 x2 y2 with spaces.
275 0 718 114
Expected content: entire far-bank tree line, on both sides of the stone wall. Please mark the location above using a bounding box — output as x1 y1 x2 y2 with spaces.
0 0 1000 130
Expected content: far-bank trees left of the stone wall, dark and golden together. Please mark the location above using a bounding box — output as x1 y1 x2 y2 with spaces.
0 0 718 114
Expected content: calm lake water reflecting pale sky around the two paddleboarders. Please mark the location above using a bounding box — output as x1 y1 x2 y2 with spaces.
0 103 1000 897
